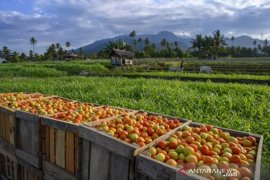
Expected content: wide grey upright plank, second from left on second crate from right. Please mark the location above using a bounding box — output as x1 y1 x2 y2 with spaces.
90 143 110 180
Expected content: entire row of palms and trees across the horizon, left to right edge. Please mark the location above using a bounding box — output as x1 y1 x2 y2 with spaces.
0 30 270 62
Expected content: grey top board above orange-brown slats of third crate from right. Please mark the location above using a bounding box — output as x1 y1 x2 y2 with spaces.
40 117 78 133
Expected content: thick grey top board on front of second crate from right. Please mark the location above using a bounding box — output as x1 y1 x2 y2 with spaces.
80 125 137 159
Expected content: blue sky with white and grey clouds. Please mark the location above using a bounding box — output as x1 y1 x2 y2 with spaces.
0 0 270 53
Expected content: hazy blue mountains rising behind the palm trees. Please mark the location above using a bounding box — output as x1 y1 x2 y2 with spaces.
75 31 261 54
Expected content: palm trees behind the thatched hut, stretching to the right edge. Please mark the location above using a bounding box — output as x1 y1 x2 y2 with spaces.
95 30 270 59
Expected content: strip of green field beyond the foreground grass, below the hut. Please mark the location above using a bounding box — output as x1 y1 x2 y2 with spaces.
0 60 270 84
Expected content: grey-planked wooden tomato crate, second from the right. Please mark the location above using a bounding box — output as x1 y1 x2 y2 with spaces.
80 114 189 180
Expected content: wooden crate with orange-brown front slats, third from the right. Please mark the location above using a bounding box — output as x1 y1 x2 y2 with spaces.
40 106 135 179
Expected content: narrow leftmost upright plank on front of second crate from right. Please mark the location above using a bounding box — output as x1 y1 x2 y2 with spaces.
82 139 91 180
